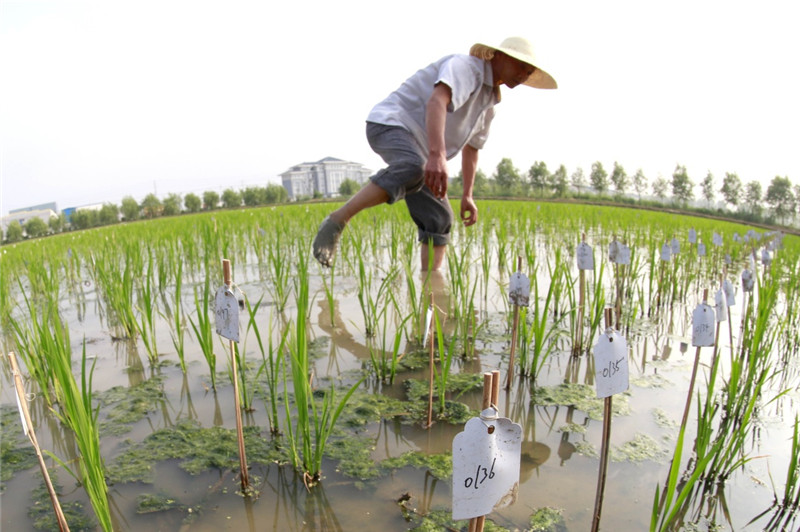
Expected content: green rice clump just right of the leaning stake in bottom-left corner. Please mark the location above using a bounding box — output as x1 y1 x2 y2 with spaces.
48 342 113 531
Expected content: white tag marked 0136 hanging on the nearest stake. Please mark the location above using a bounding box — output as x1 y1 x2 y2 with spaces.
453 416 522 521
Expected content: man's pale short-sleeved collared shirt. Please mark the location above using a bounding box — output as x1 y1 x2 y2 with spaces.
367 54 499 159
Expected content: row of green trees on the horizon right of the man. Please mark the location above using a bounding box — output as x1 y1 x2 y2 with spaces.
454 158 800 223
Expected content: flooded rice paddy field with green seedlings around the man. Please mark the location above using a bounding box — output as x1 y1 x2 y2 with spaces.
0 201 800 531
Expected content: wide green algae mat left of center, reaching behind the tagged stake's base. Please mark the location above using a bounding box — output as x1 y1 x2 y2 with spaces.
108 421 288 483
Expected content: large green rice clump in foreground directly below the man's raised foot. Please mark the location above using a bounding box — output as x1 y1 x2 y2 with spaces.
284 255 363 487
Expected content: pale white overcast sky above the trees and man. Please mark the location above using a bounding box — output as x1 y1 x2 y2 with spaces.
0 0 800 215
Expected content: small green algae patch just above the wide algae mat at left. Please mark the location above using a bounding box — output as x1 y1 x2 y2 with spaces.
98 376 164 436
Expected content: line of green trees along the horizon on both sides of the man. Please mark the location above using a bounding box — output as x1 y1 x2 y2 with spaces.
3 158 800 242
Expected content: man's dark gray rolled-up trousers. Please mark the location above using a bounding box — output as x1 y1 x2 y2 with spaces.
367 122 453 246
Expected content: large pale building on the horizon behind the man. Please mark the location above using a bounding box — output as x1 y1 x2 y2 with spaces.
281 157 372 200
